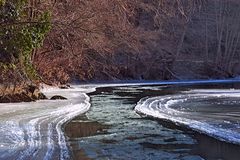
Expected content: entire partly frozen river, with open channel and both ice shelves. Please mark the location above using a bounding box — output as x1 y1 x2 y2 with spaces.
0 81 240 160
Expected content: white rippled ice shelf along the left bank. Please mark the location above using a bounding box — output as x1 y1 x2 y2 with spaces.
0 87 94 159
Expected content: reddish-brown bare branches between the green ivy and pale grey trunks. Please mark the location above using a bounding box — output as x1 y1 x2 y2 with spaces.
35 0 205 83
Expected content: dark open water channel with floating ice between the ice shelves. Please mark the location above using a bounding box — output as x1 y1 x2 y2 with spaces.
65 84 240 160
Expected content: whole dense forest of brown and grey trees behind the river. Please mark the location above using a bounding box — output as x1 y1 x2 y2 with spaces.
0 0 240 100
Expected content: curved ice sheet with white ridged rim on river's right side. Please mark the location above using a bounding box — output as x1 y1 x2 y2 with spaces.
135 89 240 144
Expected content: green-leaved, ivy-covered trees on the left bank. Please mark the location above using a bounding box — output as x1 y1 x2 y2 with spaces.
0 0 51 84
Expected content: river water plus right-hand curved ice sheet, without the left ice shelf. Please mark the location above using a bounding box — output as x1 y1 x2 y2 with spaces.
65 83 240 160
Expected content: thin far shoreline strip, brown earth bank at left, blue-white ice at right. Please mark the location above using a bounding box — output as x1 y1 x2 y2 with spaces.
0 78 240 103
